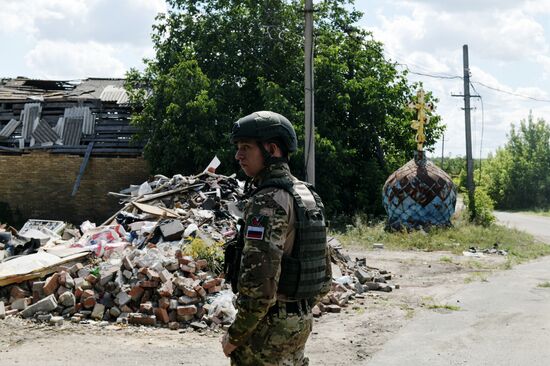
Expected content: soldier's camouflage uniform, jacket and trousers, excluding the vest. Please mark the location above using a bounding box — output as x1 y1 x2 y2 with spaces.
228 163 313 365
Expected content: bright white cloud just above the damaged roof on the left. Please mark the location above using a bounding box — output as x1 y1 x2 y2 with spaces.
25 41 127 79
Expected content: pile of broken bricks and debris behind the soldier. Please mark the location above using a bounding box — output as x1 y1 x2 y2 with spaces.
0 164 394 329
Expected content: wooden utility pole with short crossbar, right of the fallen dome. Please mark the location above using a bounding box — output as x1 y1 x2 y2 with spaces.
452 44 479 220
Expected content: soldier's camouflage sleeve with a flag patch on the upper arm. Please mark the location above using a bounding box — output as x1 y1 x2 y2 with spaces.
228 191 288 346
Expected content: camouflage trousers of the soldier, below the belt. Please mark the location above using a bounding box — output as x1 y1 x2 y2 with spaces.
231 311 313 366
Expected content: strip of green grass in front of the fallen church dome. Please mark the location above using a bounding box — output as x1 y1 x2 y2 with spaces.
334 214 550 268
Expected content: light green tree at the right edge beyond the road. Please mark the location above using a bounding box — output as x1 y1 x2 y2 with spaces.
484 114 550 209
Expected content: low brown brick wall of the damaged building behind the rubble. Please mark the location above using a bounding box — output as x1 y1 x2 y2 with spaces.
0 152 148 228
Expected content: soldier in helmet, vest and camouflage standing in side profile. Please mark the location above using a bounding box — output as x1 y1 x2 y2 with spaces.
221 111 332 365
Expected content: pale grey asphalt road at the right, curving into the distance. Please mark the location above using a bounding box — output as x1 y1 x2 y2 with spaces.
368 213 550 366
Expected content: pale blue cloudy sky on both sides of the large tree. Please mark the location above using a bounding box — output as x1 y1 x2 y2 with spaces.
0 0 550 157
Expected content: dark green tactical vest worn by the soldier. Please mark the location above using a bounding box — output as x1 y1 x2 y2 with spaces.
253 176 327 300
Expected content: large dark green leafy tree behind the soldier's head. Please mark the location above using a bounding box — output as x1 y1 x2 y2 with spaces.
127 0 443 216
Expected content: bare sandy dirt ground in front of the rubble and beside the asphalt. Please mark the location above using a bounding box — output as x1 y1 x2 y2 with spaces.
0 250 505 366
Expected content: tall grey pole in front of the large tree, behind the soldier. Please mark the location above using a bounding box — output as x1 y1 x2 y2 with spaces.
304 0 315 185
